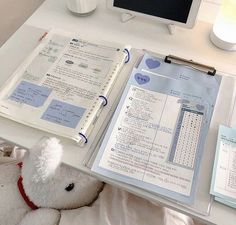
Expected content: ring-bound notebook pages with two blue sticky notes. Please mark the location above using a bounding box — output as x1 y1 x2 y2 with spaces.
0 30 129 142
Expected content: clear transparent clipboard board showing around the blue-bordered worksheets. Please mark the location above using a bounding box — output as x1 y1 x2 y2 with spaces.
84 49 235 216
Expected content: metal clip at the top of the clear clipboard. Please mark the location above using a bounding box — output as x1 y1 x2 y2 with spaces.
164 55 216 76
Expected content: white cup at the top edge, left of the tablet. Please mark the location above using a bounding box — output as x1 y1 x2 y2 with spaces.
66 0 97 15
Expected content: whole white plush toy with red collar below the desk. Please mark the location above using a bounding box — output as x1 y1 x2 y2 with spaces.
0 138 103 225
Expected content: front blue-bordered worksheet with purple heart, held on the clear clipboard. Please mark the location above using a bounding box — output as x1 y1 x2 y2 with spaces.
92 60 221 204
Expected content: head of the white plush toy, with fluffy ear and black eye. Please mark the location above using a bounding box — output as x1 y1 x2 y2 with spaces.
21 138 103 209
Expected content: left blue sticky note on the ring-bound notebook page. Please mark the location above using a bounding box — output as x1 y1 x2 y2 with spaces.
9 81 52 107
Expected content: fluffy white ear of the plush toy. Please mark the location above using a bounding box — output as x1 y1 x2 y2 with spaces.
24 138 63 182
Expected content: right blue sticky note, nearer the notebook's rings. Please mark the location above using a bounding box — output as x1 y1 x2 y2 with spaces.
41 99 86 128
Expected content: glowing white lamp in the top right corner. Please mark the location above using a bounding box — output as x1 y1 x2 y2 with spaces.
210 0 236 51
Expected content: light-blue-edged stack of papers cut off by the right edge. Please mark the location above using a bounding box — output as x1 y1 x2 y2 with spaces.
210 125 236 208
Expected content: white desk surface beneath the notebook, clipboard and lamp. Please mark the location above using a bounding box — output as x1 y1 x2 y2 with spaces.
0 0 236 225
